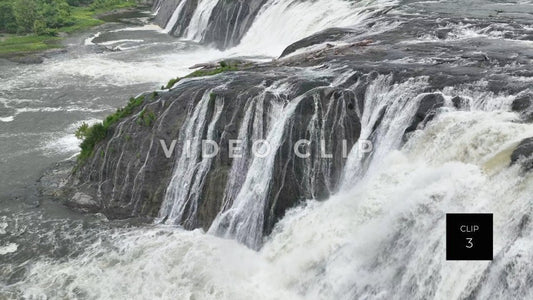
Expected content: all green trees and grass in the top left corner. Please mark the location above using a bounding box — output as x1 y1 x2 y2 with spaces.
0 0 136 55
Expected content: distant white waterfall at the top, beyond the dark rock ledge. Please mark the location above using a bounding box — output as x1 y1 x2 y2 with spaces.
157 0 396 52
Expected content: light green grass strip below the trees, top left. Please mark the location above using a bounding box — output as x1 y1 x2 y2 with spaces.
0 1 137 56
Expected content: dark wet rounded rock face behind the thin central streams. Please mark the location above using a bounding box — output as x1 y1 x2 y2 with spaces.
67 71 362 232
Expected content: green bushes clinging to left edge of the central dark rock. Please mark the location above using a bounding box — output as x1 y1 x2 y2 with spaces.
75 95 148 162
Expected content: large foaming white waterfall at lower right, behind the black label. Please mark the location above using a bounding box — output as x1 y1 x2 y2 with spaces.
261 110 533 299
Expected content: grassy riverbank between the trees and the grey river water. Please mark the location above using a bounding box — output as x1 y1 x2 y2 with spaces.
0 2 148 62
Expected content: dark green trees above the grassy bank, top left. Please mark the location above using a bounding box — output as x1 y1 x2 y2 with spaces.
0 0 134 35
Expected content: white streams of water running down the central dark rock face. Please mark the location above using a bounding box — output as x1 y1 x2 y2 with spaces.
159 72 442 249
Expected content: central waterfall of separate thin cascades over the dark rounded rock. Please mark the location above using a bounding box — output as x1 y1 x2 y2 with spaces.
154 72 440 249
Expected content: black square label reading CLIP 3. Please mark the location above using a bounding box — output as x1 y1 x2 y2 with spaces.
446 214 493 260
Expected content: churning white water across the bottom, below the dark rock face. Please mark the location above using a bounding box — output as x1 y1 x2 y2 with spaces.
10 106 533 299
